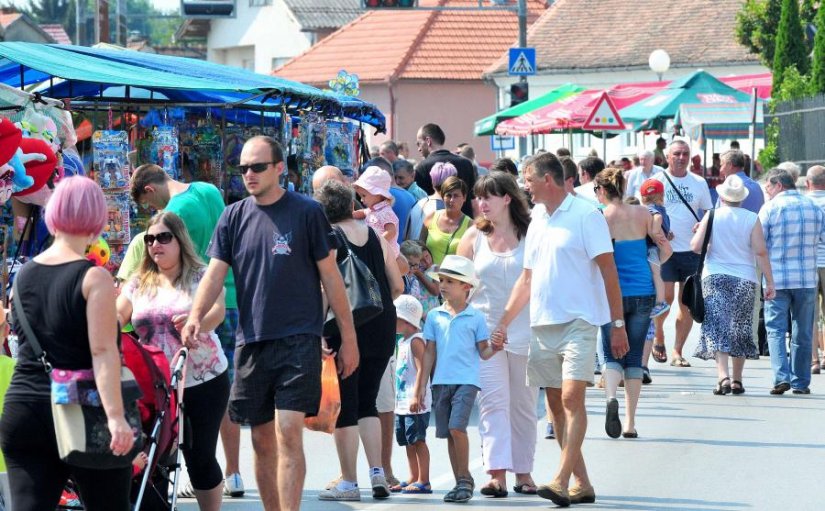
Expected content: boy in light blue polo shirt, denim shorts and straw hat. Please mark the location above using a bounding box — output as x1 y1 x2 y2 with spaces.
410 255 504 502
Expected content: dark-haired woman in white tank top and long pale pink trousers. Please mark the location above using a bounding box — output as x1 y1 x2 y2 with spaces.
458 171 538 497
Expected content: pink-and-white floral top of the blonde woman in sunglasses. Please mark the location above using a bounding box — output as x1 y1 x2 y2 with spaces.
121 270 229 387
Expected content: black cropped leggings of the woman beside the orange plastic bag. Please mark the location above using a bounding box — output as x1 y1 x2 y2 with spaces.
335 356 390 429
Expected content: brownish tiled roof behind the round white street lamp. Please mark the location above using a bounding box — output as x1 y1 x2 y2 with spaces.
486 0 759 74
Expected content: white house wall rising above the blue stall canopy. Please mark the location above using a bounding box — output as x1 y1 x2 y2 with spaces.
206 0 314 74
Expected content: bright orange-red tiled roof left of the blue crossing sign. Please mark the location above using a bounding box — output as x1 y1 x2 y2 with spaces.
273 0 545 84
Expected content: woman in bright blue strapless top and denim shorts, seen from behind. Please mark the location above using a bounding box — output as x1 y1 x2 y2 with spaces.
594 167 672 438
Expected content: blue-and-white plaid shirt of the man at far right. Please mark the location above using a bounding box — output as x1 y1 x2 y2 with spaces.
759 190 825 289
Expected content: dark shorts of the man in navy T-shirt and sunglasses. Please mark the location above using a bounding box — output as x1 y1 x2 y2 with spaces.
229 334 321 426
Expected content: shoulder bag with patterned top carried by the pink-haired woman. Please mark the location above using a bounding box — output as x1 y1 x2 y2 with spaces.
12 279 143 469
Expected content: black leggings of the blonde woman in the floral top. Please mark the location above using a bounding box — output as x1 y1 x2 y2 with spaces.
183 371 229 490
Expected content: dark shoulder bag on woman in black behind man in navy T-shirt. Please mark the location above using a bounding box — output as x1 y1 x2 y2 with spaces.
324 227 384 337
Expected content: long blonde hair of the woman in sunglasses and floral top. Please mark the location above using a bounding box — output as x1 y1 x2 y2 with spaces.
137 212 206 296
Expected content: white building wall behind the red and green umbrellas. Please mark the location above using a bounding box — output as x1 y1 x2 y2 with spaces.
494 64 769 161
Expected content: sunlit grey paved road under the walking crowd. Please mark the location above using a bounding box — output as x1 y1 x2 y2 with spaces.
180 318 825 511
